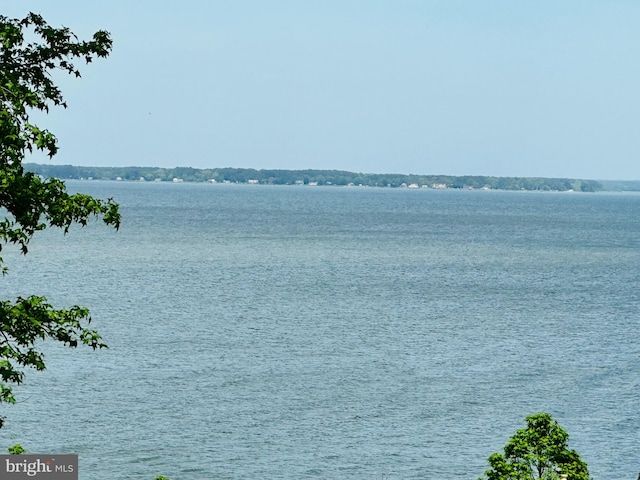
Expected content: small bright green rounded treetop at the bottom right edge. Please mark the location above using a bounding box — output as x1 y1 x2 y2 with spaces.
480 413 590 480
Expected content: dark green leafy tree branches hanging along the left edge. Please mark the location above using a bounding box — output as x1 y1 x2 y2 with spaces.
0 13 120 426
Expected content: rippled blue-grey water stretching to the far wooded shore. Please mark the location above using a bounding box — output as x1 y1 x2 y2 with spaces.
0 182 640 480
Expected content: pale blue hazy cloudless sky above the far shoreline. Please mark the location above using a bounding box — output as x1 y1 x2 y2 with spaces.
5 0 640 179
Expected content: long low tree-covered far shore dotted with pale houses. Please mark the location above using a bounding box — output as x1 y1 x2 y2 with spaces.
24 163 605 192
